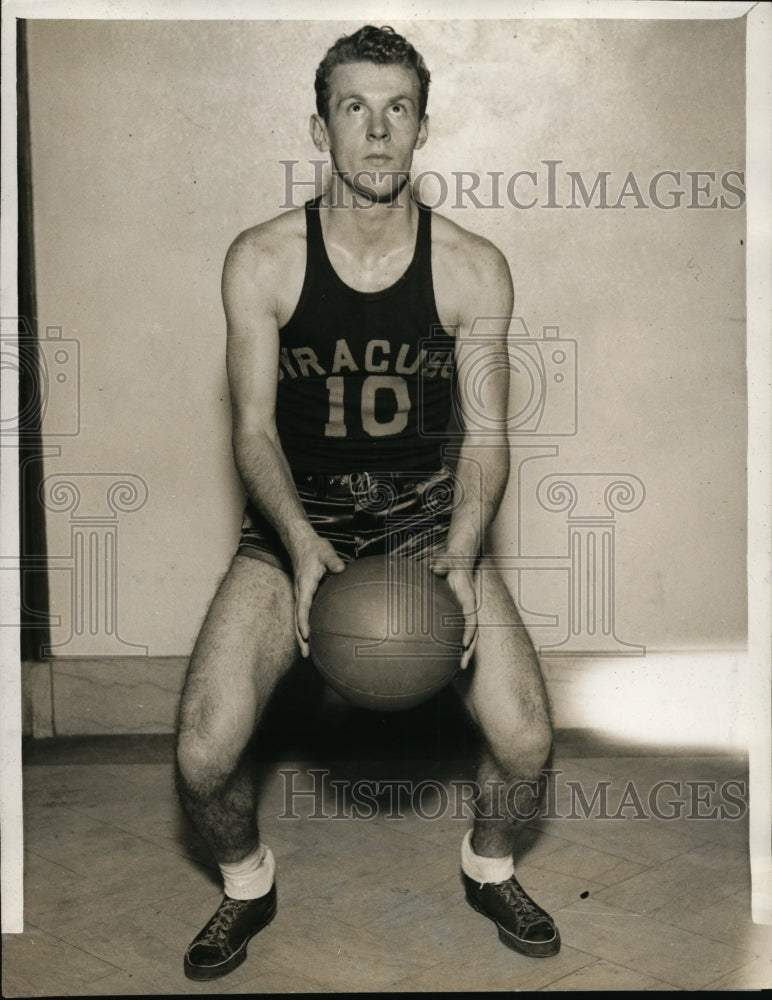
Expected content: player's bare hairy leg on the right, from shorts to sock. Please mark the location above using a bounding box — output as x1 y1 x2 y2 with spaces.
457 567 552 858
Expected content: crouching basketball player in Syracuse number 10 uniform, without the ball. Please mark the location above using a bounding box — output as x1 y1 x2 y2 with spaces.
177 26 560 980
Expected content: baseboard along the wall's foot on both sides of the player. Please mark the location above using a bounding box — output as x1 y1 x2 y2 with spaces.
22 650 753 750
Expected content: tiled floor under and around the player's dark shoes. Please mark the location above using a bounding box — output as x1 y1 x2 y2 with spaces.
3 696 772 997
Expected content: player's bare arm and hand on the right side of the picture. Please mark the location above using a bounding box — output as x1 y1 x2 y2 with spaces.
434 238 514 667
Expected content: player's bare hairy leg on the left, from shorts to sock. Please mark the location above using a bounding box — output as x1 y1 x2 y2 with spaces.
177 556 298 863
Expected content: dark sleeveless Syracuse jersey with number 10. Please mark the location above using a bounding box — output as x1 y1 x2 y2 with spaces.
276 198 455 474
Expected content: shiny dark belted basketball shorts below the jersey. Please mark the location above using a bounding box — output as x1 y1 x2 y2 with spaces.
237 466 460 575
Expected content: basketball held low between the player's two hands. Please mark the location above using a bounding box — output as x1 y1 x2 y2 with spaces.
309 556 464 711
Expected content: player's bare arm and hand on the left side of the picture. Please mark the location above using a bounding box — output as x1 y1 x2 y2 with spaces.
222 235 344 656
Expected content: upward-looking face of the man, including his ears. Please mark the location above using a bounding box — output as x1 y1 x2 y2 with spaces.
311 62 428 200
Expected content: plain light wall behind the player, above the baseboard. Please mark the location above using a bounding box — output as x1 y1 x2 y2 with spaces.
29 19 746 656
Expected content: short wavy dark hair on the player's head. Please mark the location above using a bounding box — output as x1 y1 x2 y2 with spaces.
314 24 431 121
